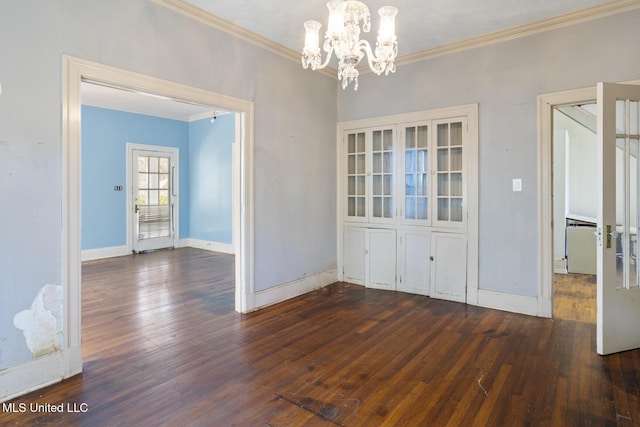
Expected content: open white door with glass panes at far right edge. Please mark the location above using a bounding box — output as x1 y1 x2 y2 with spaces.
596 83 640 354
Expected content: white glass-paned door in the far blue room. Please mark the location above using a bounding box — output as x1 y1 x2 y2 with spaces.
131 148 178 252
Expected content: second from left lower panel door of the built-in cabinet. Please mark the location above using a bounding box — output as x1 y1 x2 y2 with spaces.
366 228 396 290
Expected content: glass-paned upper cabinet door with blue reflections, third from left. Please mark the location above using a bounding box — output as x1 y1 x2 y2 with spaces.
404 124 430 225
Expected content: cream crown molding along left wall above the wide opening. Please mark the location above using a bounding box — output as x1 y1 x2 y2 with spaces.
152 0 338 79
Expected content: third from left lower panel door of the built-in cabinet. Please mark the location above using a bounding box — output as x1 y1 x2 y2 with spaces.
397 230 431 295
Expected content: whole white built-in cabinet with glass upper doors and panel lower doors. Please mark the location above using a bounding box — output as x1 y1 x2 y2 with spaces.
338 106 477 302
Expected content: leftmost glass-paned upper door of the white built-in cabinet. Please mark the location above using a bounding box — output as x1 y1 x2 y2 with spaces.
347 132 367 219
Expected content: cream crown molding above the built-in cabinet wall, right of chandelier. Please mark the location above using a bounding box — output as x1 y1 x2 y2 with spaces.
392 0 640 72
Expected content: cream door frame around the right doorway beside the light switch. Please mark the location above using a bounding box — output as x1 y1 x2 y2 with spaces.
537 80 640 317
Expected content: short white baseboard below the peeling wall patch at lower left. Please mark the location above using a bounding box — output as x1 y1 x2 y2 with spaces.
0 347 82 402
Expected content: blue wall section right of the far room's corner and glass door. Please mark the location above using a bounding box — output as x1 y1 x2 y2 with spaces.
189 114 235 244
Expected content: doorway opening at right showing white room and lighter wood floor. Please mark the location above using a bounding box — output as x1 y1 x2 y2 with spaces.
551 102 598 324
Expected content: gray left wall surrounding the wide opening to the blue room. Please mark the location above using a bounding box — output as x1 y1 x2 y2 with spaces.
0 0 337 369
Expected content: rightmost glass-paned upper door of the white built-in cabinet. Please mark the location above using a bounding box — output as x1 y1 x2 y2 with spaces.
436 121 464 224
